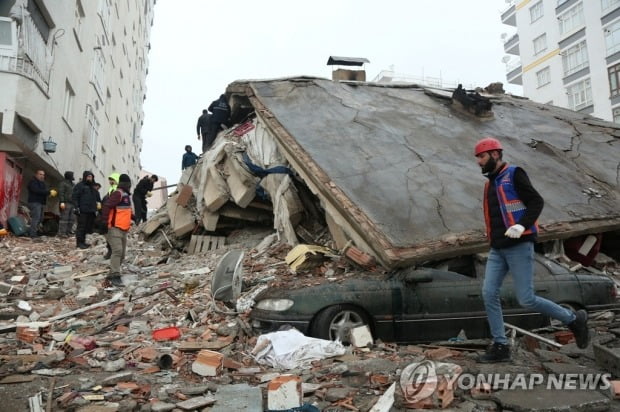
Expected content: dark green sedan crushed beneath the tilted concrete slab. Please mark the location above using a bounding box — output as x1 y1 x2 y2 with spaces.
250 255 618 343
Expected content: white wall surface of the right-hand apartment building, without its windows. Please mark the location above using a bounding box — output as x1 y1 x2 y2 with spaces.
504 0 620 120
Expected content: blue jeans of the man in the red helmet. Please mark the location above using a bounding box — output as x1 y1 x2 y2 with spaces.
482 242 575 344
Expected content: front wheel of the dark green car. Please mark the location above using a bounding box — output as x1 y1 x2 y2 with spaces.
311 305 370 344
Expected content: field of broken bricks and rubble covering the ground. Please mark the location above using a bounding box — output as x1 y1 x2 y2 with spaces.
0 229 620 412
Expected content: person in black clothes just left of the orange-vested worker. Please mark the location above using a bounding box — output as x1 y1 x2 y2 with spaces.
73 170 98 249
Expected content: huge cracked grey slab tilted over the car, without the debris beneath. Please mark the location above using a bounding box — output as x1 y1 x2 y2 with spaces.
227 78 620 267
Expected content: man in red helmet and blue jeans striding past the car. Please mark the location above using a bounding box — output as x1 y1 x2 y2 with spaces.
474 137 589 363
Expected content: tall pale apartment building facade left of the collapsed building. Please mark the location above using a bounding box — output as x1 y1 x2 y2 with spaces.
0 0 156 222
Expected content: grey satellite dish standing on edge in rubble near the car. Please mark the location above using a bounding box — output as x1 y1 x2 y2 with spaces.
211 250 244 302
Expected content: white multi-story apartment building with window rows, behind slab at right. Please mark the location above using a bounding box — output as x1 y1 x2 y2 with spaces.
501 0 620 123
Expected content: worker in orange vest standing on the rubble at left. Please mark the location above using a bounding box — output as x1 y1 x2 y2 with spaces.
101 174 132 287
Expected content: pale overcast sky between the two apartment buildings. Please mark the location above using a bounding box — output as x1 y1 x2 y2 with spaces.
141 0 521 184
